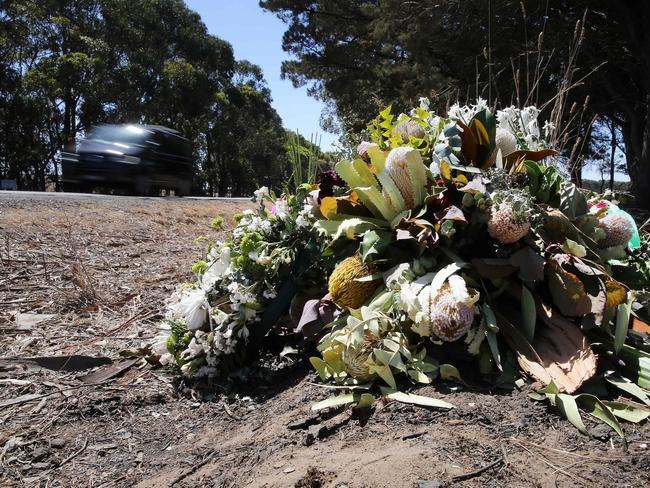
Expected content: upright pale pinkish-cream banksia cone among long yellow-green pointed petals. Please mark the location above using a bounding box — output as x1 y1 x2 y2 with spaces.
379 146 427 210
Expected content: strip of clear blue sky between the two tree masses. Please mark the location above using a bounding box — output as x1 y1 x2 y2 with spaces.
185 0 338 151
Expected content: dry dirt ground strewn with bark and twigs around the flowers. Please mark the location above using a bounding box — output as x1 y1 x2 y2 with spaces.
0 196 650 488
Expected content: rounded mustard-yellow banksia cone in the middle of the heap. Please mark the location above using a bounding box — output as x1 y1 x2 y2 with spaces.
329 255 379 308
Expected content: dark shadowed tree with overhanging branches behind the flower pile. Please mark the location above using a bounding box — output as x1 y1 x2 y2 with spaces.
260 0 650 206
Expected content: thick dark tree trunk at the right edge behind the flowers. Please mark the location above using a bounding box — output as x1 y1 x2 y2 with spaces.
623 94 650 209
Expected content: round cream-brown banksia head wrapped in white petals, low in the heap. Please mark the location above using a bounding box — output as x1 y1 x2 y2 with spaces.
418 275 479 342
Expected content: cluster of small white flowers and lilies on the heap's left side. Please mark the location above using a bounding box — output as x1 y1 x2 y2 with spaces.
153 188 314 376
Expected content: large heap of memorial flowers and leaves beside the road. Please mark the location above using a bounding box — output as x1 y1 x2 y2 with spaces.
153 99 650 436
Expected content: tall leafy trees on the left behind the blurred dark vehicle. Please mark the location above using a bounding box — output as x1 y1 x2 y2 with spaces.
0 0 286 195
